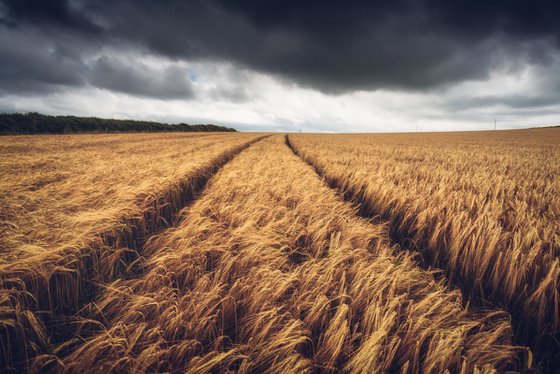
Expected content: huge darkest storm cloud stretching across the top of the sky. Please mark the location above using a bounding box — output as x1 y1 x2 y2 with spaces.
0 0 560 93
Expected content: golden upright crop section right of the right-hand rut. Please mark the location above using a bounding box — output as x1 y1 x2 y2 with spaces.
289 129 560 367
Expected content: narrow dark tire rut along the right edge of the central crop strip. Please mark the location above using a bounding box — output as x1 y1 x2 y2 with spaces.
285 135 532 362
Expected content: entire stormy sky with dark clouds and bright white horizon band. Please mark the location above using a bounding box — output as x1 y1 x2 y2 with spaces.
0 0 560 132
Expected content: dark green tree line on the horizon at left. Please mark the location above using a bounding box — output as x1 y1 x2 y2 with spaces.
0 113 237 135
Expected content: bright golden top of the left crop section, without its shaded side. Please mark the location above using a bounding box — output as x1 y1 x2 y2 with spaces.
0 133 256 266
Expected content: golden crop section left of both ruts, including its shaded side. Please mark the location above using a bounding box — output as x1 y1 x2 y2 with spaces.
0 134 264 369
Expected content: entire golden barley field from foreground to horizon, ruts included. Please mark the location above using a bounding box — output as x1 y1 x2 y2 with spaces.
0 129 560 373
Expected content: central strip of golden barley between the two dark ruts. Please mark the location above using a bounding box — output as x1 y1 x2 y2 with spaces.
54 135 521 373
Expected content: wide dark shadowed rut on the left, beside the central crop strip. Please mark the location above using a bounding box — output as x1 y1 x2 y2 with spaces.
0 135 270 373
